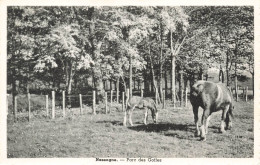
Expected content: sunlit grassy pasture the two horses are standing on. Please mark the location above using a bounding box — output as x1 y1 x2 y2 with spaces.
7 101 254 158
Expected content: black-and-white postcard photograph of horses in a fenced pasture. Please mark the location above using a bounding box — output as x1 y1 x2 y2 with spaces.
1 0 259 163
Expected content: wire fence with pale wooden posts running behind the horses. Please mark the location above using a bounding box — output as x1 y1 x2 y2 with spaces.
7 87 253 121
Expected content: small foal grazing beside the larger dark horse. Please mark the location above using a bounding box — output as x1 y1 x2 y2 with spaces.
123 96 158 126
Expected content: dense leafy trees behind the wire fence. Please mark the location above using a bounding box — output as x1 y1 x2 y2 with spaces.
7 6 254 98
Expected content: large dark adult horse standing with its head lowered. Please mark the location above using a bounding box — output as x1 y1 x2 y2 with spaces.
190 80 234 140
